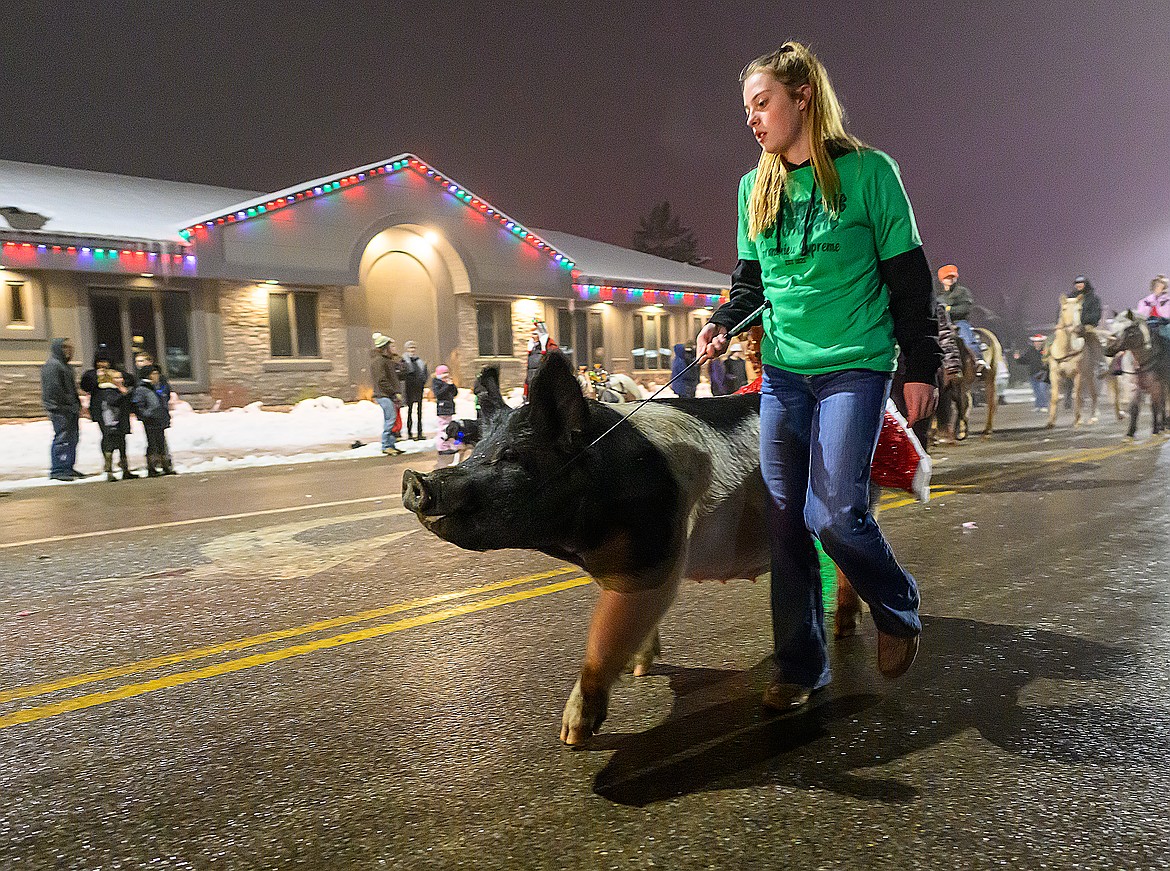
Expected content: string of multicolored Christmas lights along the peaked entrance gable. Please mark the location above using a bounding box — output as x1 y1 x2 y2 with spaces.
179 155 574 269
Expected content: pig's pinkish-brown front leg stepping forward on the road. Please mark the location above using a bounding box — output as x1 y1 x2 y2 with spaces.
560 578 679 746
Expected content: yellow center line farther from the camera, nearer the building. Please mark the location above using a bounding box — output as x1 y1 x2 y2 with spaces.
0 565 579 704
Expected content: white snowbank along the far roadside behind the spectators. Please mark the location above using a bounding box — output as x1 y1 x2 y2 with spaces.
0 382 1032 491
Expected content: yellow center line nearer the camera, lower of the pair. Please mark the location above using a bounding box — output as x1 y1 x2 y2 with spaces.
0 577 593 729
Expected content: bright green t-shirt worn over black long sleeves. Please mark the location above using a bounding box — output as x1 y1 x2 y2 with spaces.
738 149 922 375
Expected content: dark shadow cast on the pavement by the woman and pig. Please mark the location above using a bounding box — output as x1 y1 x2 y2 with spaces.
593 617 1170 807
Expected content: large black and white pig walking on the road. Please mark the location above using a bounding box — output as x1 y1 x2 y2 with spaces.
402 352 770 745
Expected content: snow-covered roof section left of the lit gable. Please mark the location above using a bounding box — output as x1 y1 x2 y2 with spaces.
0 160 260 242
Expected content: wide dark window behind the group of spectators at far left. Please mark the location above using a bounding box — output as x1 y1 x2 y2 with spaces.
89 289 195 380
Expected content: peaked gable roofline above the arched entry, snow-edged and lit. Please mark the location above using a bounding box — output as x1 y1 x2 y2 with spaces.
179 152 576 269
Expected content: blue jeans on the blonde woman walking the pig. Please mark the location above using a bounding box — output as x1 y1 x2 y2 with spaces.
759 366 922 687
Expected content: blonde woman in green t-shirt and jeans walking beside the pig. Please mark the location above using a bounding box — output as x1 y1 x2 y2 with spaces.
697 42 942 711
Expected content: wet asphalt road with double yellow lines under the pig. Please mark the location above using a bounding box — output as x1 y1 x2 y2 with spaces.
0 406 1170 869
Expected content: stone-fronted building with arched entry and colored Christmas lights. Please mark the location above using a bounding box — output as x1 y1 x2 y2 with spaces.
0 155 730 417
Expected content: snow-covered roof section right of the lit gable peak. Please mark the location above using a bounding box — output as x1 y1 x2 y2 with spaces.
532 227 731 292
